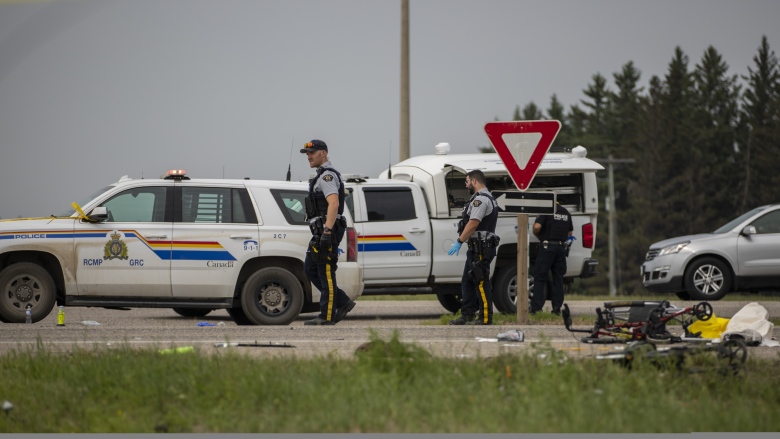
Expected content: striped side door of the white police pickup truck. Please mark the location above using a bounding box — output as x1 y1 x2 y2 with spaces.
355 185 432 285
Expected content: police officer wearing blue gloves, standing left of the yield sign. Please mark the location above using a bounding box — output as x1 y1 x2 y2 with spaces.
447 170 498 325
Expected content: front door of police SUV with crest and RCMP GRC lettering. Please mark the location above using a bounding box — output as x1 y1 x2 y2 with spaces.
75 183 173 297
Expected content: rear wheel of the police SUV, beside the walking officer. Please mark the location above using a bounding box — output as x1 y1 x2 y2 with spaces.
241 267 303 325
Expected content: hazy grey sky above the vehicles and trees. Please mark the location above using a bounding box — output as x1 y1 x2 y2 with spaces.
0 0 780 218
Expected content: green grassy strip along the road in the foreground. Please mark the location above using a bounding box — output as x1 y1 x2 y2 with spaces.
0 336 780 433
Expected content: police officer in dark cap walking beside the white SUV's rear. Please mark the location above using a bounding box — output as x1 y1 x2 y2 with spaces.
301 139 355 326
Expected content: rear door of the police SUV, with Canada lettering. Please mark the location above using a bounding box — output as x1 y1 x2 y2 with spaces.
171 184 259 298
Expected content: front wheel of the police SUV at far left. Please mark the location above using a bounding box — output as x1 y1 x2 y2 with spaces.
0 262 57 323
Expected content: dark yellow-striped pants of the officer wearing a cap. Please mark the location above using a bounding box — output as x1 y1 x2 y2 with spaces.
303 229 350 321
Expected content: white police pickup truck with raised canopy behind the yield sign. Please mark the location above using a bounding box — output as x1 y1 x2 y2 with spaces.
344 144 604 313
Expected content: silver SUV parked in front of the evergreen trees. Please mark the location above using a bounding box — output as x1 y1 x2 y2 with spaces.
640 203 780 300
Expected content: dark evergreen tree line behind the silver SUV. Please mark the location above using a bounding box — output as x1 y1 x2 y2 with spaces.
494 36 780 295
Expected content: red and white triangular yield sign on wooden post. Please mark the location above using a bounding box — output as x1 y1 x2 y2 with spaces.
485 120 561 192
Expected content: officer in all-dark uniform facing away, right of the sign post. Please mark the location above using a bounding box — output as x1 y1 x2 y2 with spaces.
530 204 574 315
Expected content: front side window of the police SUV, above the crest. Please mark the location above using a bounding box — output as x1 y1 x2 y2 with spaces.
101 187 167 223
